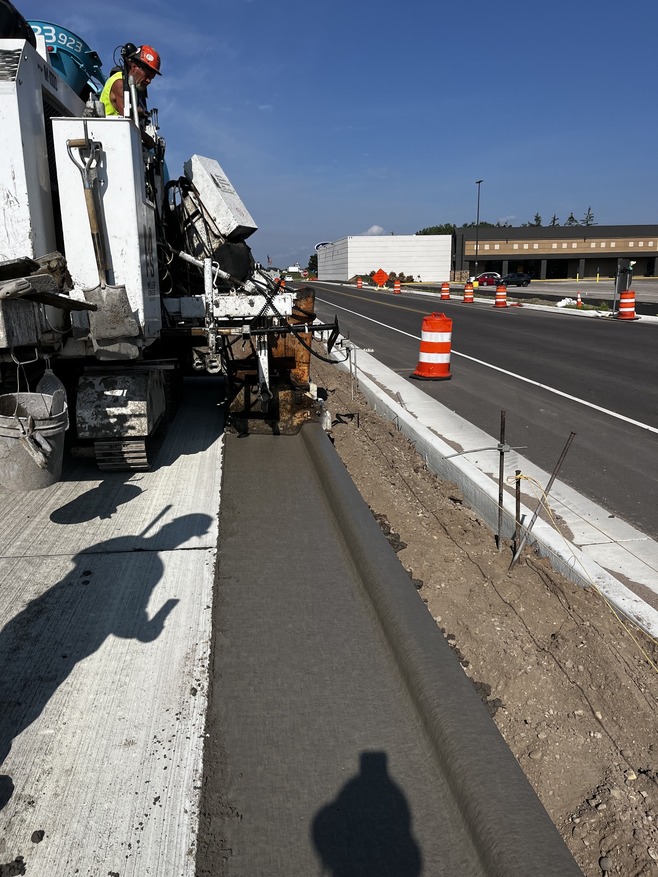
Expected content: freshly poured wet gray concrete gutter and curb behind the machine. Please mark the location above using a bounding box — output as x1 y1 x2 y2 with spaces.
197 424 581 877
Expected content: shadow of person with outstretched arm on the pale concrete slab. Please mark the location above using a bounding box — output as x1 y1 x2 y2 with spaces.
0 510 212 810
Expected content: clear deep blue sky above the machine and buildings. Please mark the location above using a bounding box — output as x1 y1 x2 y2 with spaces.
21 0 658 266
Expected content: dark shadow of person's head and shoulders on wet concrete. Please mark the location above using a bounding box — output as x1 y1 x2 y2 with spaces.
311 752 422 877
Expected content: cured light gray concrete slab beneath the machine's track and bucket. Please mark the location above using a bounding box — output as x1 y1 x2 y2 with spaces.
0 384 223 877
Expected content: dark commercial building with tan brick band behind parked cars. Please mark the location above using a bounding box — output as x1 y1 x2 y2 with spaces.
452 225 658 280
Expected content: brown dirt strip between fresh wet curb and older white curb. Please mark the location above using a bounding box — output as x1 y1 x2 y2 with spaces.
313 352 658 877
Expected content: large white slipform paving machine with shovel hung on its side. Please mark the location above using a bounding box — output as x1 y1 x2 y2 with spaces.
0 3 338 469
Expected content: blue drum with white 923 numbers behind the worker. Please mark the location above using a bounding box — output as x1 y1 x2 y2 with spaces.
28 20 105 99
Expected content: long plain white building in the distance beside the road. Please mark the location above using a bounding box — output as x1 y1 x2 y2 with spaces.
318 235 452 283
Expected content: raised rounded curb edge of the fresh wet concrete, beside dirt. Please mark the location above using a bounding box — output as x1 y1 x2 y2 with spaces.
302 424 582 877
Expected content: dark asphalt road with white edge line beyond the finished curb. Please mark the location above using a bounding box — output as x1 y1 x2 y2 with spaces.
308 283 658 539
